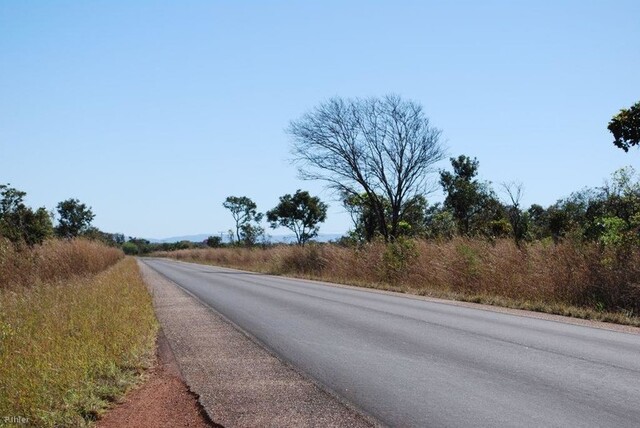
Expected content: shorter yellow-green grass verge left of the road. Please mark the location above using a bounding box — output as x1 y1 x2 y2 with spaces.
0 256 157 426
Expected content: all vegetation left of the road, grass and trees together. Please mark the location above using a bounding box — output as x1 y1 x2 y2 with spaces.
0 189 156 427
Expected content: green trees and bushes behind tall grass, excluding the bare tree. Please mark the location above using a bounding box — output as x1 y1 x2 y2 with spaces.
344 155 640 245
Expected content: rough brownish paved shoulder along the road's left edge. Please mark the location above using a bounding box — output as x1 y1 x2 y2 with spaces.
139 262 371 427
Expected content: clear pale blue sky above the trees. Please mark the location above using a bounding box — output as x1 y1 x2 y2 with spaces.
0 0 640 238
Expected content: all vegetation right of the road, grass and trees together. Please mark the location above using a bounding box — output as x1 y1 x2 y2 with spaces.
154 95 640 325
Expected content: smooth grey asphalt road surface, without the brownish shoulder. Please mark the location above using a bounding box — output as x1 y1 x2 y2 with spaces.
145 259 640 427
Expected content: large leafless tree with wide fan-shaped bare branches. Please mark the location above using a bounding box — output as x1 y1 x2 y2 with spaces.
288 95 445 240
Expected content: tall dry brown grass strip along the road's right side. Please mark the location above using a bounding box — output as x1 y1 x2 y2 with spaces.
158 238 640 324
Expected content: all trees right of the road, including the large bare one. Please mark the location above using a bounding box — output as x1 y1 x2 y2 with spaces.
216 95 640 249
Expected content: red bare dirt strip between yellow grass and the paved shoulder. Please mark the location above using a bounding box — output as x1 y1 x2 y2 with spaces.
97 332 220 428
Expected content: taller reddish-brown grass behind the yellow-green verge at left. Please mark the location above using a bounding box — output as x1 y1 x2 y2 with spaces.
0 237 124 289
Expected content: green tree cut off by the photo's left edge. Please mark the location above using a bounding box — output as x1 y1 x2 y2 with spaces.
0 184 53 245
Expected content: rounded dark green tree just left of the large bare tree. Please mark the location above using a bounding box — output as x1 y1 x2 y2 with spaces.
267 189 327 245
